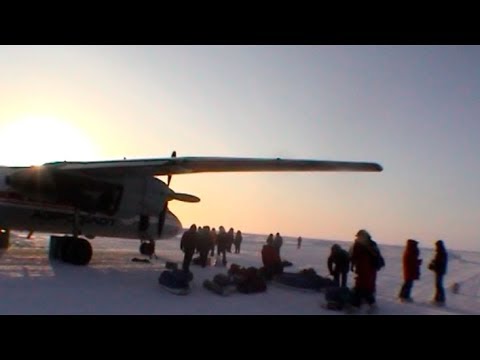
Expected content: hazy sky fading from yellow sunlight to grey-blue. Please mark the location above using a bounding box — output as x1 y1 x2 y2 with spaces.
0 45 480 251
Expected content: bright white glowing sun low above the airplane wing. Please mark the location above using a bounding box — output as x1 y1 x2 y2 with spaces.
0 116 98 166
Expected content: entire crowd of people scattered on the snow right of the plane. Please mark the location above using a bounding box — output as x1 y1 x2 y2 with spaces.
180 224 448 308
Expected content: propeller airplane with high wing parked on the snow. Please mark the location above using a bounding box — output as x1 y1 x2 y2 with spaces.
0 151 383 265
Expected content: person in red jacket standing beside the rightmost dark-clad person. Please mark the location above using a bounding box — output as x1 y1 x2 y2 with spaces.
398 239 422 302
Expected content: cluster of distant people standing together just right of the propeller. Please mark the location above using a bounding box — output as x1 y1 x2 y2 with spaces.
180 224 243 271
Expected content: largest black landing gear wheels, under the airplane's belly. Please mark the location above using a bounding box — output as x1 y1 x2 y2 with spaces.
49 236 93 265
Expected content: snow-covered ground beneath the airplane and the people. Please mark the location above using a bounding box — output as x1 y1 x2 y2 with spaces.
0 233 480 315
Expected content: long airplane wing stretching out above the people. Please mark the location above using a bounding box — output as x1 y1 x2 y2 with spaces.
44 157 383 177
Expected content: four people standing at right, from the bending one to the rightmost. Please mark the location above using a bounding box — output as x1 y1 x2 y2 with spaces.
327 230 448 308
